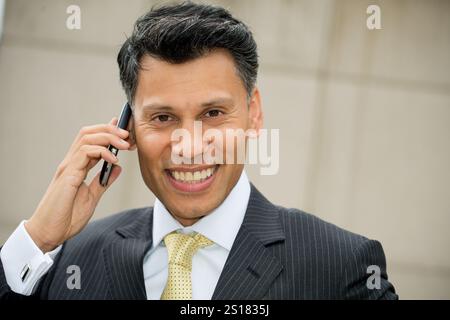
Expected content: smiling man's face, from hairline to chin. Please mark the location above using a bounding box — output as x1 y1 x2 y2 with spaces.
133 50 262 226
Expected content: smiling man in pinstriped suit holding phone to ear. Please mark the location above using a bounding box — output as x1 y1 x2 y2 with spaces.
0 3 397 299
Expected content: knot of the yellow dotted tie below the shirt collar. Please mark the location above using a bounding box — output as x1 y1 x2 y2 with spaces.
164 232 213 270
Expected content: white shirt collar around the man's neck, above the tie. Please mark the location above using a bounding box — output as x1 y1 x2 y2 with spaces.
152 170 250 251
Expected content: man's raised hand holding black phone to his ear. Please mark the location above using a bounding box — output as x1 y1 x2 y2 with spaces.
25 118 134 252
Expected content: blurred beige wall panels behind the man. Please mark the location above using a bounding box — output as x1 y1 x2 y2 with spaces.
0 0 450 299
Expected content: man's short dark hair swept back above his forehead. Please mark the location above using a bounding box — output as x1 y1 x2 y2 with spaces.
117 2 258 104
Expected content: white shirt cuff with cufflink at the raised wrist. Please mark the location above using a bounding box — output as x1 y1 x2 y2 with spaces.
0 220 62 296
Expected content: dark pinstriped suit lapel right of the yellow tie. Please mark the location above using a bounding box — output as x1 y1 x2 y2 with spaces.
212 185 285 300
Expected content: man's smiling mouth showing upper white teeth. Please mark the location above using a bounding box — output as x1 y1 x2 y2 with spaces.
165 165 219 192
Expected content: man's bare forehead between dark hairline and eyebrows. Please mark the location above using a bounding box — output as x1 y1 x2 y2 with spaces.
136 50 246 108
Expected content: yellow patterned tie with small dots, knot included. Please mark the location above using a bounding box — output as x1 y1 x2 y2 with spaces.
161 232 213 300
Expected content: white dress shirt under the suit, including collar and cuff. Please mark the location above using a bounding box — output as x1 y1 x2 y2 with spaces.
0 171 250 300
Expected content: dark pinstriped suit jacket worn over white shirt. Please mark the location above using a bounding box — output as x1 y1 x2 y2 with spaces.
0 185 398 299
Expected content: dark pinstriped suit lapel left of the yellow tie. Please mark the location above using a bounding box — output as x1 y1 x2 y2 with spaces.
103 208 153 300
